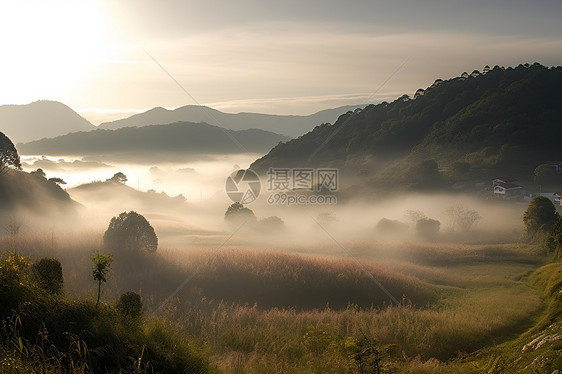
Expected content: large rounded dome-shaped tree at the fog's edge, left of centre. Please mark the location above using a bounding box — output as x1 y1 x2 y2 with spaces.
103 211 158 253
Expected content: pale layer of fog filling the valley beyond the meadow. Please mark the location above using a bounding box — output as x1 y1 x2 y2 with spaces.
15 154 526 255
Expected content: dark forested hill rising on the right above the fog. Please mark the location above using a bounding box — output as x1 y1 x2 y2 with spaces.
251 63 562 188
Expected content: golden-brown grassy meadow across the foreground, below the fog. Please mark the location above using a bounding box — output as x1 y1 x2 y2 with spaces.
0 226 545 373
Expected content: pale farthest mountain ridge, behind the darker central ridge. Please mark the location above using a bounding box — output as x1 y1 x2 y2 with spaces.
98 105 365 137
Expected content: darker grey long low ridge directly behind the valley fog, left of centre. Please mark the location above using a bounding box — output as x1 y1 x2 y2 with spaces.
18 122 290 155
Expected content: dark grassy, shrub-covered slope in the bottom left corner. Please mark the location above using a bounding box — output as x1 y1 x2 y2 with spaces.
0 252 209 373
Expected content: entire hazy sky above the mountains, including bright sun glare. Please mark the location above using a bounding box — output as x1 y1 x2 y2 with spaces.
0 0 562 125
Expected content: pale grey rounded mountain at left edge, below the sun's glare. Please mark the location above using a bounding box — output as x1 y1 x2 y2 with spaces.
0 100 96 143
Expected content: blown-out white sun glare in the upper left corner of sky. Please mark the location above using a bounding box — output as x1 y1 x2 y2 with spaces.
0 0 107 103
